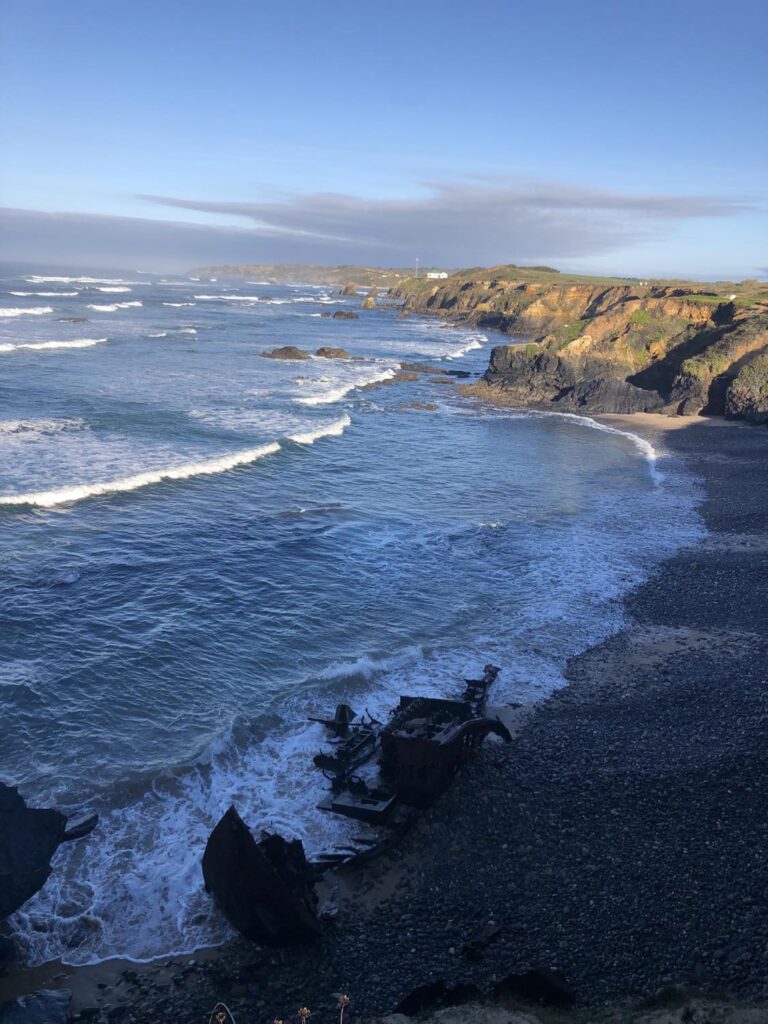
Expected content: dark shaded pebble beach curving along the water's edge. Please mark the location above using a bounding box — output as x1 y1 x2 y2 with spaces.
3 416 768 1024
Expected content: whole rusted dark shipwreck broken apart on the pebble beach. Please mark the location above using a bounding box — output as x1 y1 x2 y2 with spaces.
203 665 512 946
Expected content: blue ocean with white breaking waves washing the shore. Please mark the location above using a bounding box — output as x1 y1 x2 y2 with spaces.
0 267 701 964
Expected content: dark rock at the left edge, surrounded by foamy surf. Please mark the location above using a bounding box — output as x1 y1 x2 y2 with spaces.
0 782 97 920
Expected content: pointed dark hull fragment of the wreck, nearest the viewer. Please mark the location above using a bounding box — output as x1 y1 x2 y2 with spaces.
203 807 322 946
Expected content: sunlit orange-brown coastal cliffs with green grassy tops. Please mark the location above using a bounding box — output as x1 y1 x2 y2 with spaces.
394 266 768 423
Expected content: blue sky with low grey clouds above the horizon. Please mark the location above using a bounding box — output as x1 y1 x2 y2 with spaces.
0 0 768 280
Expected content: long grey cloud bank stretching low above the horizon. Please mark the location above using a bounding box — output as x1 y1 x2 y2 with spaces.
0 177 751 269
